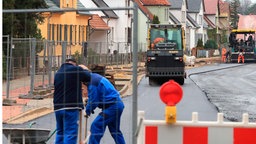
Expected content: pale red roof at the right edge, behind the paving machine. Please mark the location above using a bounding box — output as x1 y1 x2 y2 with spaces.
238 15 256 30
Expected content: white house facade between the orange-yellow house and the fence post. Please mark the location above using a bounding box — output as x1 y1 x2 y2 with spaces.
81 0 132 54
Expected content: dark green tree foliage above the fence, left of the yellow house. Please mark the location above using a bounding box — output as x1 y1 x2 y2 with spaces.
3 0 47 39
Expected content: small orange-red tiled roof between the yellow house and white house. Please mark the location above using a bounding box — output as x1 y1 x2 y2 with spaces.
89 14 110 30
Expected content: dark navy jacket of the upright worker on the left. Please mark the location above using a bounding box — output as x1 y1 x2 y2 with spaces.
53 63 91 111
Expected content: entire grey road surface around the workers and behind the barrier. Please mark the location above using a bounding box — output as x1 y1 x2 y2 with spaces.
3 64 256 144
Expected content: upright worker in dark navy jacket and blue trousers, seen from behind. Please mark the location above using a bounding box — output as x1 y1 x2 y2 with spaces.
53 59 91 144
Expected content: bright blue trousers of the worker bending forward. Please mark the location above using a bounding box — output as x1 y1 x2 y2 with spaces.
88 102 125 144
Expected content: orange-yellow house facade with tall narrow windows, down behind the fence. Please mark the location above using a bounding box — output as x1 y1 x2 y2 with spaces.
37 0 92 68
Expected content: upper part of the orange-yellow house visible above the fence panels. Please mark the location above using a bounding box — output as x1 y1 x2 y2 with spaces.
38 0 91 56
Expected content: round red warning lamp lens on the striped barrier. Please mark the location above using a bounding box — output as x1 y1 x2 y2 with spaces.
159 80 183 106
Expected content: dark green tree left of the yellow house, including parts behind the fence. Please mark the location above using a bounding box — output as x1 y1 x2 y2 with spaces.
2 0 47 80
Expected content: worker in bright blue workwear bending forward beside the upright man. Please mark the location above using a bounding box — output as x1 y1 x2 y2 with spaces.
79 67 125 144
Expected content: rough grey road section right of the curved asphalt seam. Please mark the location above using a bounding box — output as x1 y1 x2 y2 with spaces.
191 64 256 122
